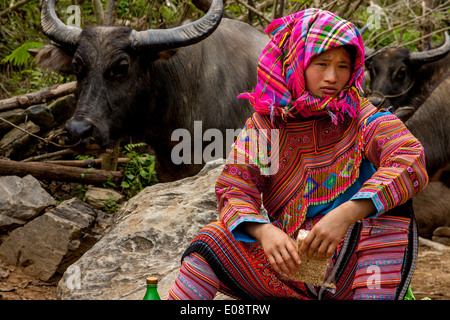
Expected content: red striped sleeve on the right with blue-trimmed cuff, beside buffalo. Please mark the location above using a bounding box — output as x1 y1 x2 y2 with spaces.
352 111 428 214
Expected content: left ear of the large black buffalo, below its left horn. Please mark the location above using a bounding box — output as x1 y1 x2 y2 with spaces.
34 45 73 74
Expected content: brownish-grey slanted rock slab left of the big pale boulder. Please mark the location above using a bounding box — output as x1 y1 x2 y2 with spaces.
0 198 99 281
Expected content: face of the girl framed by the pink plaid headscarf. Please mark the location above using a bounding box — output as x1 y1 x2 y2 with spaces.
305 47 352 98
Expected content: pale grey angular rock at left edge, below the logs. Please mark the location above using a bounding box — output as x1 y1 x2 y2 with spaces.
0 175 56 231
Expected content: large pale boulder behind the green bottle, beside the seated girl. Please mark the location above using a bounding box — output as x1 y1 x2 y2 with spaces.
58 160 223 300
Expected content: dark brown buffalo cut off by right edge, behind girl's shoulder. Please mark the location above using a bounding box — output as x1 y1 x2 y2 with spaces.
367 34 450 238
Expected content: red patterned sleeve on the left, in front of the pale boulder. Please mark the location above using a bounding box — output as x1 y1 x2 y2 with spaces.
216 118 269 242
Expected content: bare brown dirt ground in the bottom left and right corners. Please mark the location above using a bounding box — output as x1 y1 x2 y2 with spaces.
0 240 450 300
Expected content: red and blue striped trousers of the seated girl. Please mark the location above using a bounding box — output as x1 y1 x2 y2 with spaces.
170 200 418 300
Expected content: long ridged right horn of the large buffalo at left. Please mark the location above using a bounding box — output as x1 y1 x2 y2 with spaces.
131 0 223 50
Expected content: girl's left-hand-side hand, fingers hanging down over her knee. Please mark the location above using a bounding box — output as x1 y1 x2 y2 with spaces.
245 223 301 276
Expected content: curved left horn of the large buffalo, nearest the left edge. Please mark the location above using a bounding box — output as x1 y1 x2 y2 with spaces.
41 0 81 46
